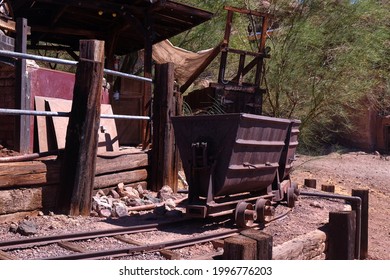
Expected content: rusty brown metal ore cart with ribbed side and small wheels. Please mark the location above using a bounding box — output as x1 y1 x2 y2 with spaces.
172 113 300 227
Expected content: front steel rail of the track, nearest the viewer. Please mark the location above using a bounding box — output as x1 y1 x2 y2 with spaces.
45 229 241 260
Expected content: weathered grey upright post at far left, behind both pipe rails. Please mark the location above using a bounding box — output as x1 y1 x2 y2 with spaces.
14 18 32 154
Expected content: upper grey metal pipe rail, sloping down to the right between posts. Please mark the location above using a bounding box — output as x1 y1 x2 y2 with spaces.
0 50 153 83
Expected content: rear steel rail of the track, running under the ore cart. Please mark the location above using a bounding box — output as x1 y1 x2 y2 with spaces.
0 218 188 250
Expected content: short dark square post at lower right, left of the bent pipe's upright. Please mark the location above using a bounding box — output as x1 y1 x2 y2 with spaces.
328 211 356 260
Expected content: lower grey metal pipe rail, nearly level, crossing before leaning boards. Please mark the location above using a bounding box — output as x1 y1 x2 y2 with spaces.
0 108 150 120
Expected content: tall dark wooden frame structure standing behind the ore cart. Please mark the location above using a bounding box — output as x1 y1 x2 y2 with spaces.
184 6 270 115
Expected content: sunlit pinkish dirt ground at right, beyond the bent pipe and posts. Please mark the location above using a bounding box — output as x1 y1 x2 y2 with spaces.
292 152 390 260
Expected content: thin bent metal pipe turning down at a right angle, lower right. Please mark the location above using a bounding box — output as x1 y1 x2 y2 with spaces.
299 191 362 259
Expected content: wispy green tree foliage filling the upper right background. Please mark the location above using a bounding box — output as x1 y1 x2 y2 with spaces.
174 0 390 152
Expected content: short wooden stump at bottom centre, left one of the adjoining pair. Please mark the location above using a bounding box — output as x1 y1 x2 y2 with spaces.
223 235 257 260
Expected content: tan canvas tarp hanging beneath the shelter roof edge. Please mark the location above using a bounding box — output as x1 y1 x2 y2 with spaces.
153 40 219 85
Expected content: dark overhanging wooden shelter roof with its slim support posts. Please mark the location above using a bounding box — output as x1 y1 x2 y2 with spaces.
0 0 212 152
